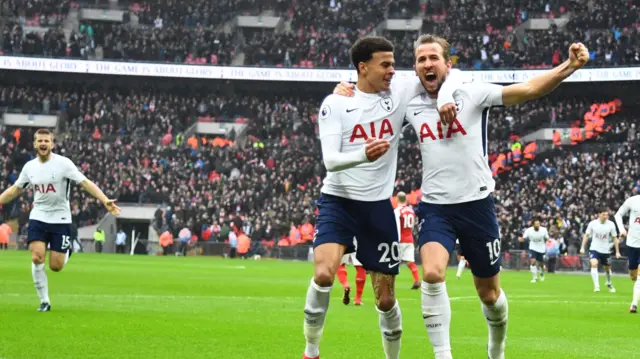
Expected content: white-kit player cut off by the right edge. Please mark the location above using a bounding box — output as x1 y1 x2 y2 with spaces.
614 195 640 314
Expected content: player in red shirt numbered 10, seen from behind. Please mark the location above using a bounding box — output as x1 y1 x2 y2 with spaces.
395 192 420 289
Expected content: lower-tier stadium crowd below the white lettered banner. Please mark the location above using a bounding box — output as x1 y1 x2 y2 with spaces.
0 78 638 258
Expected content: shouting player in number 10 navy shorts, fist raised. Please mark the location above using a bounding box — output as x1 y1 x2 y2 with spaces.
334 35 589 359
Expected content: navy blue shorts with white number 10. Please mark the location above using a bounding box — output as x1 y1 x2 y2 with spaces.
418 195 501 278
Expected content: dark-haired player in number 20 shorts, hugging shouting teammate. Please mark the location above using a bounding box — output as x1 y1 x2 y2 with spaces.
303 37 423 359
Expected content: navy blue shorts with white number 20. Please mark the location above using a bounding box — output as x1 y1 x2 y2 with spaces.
313 193 400 274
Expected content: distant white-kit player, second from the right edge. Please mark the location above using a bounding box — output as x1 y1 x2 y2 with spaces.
580 209 620 293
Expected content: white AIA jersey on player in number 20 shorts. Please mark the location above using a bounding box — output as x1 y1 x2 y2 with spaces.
318 77 424 202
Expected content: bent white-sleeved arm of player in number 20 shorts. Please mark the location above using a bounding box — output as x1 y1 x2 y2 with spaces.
318 95 369 172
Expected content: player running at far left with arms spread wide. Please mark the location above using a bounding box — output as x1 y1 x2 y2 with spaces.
0 129 120 312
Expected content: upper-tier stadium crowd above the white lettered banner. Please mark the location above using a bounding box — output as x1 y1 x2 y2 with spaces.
3 0 640 69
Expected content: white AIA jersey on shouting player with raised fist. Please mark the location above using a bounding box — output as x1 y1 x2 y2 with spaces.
407 83 502 204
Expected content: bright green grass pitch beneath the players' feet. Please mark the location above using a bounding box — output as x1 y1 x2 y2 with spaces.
0 251 640 359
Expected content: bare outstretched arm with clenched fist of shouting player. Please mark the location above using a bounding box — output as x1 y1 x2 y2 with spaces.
502 43 589 106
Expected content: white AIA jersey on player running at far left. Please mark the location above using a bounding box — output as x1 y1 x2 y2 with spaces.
14 153 86 223
